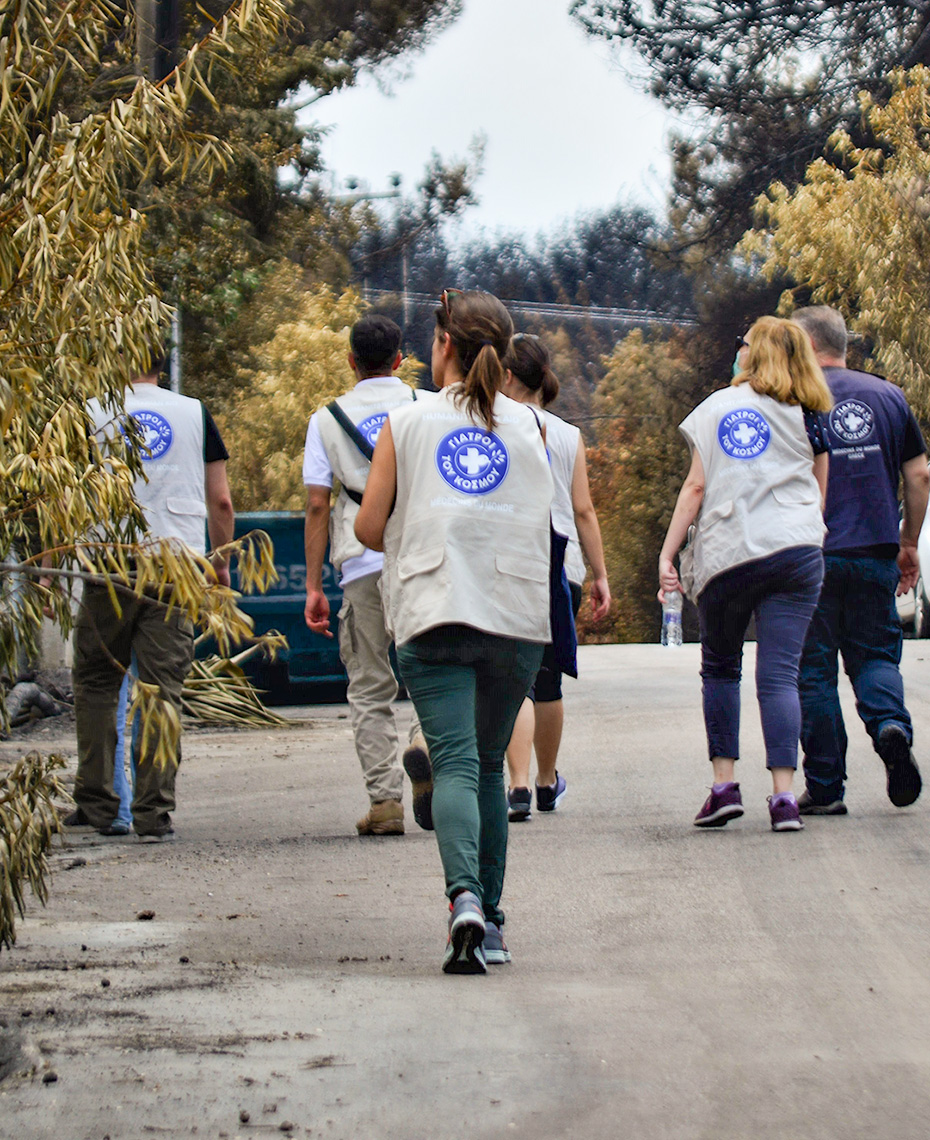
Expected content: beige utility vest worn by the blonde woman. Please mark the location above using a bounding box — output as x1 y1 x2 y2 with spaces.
680 384 826 597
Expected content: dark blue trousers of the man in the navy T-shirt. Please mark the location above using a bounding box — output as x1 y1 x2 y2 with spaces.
800 554 913 804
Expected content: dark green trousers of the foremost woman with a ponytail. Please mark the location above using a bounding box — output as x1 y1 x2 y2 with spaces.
397 626 543 925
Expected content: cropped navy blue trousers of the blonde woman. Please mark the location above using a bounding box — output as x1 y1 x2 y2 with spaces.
698 546 823 768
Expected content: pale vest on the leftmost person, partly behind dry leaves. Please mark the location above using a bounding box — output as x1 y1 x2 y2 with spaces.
88 383 206 554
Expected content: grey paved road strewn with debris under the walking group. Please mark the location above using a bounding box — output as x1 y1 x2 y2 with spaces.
0 642 930 1140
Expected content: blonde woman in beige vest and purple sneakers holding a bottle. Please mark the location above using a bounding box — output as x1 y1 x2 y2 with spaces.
659 317 832 831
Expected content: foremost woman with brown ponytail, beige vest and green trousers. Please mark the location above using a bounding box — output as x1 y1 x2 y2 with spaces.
356 290 553 974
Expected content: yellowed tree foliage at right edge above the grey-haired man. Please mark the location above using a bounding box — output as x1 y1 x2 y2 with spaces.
742 67 930 420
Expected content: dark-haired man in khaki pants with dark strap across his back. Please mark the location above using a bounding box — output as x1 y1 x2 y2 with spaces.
303 315 414 836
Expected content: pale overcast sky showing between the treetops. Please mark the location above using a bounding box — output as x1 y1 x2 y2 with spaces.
305 0 674 240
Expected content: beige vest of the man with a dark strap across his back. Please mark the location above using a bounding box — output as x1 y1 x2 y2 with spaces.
317 380 414 570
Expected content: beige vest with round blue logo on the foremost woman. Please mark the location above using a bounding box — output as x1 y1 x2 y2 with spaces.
382 385 553 645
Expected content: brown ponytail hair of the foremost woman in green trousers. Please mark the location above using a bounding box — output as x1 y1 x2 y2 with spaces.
435 290 513 431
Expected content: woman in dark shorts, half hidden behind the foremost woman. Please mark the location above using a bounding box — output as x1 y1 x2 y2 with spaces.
501 333 611 822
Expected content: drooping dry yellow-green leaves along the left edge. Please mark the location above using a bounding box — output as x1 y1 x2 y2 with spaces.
0 0 286 945
